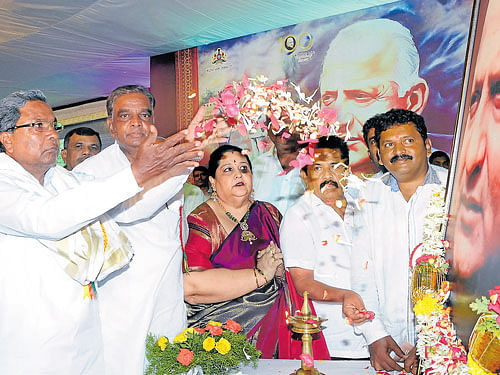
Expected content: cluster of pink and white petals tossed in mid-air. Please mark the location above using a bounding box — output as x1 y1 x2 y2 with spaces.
203 75 344 168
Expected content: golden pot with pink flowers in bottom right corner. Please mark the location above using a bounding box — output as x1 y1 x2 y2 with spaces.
469 285 500 374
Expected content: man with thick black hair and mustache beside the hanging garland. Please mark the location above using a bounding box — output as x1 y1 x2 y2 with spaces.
351 109 447 373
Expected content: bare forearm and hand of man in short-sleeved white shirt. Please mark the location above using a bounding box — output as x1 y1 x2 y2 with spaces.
289 267 368 324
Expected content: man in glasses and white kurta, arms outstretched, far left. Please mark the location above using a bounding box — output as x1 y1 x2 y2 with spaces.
0 90 200 375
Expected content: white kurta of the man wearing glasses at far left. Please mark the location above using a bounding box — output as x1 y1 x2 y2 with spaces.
0 153 140 375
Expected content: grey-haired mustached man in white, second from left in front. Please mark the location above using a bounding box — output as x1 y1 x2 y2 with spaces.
75 85 223 374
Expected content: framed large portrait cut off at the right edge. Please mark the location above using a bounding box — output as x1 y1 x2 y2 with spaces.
446 0 500 343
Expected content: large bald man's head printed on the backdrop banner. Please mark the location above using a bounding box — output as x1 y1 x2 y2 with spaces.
320 19 429 173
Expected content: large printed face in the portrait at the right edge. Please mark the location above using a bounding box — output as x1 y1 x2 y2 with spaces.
447 1 500 290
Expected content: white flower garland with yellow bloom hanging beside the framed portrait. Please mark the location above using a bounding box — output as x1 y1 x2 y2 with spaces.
412 188 469 375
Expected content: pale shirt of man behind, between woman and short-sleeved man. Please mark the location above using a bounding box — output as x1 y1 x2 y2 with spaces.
252 148 305 215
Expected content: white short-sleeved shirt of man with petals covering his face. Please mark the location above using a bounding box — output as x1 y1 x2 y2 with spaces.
280 189 369 358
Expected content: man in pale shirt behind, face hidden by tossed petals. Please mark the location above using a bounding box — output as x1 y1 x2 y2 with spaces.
252 129 305 215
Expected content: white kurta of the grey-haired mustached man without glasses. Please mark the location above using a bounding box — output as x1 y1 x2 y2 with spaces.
75 144 187 375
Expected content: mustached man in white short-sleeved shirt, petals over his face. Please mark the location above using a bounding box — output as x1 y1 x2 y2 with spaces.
280 136 368 358
